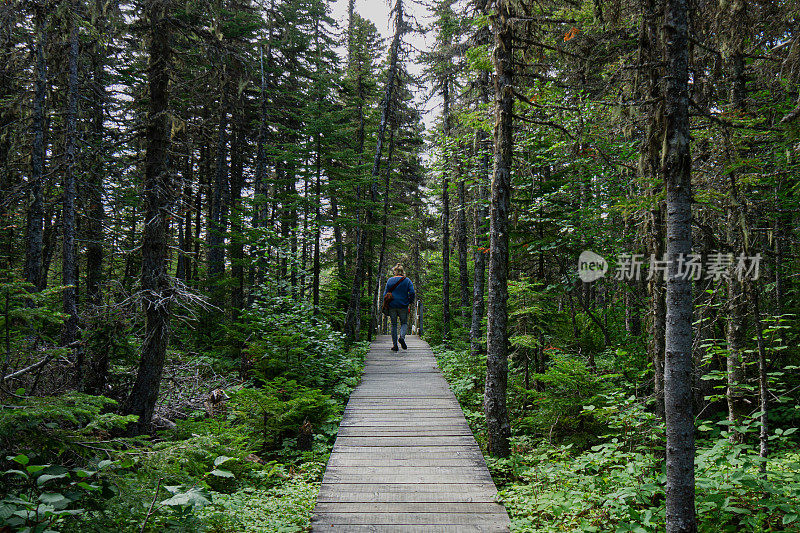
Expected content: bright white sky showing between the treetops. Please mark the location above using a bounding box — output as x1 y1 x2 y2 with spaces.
331 0 438 129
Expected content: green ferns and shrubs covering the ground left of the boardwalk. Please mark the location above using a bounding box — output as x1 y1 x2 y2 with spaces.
0 309 368 533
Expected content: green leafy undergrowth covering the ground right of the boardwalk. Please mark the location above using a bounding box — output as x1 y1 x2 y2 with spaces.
434 347 800 533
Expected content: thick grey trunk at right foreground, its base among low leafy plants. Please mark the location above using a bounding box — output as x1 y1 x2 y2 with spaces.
663 0 697 533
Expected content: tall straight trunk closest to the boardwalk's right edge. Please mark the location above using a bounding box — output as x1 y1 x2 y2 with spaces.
483 0 514 457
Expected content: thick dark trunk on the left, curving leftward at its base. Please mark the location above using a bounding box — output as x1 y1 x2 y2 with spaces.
124 0 174 435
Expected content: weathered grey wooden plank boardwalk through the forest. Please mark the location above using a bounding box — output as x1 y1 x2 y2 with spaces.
312 335 510 533
